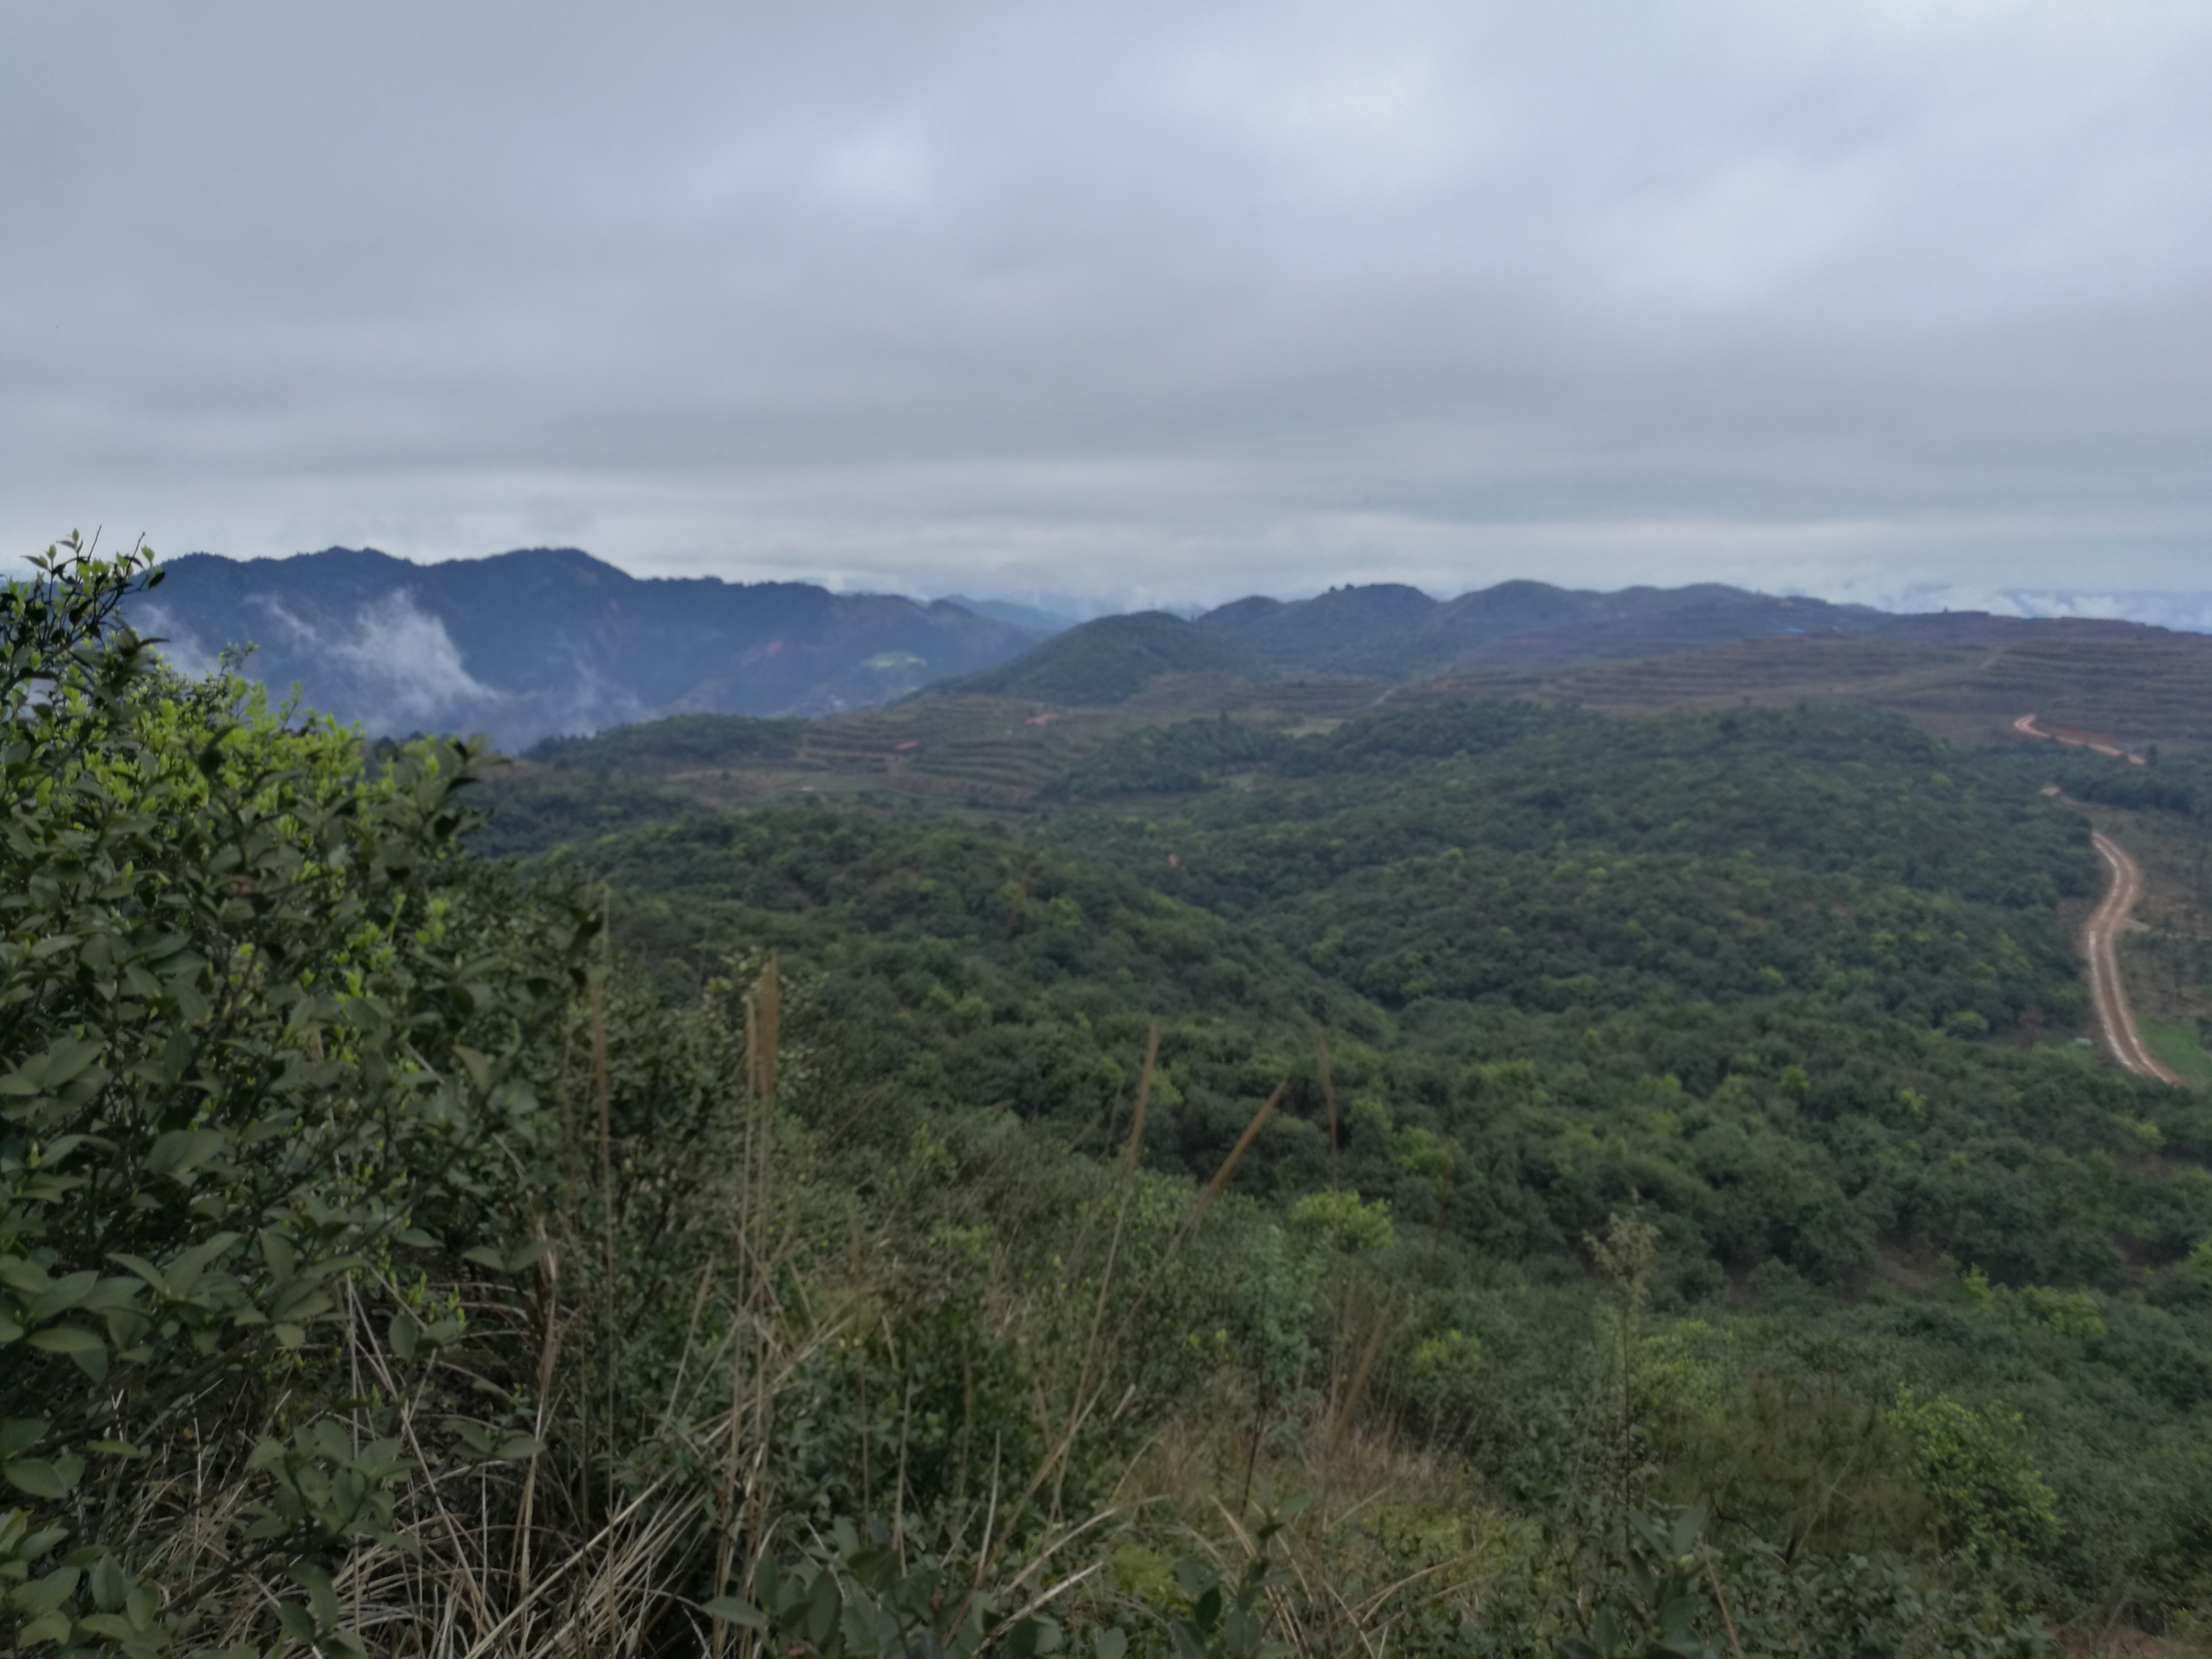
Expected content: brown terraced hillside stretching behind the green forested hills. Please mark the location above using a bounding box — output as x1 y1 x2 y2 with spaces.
497 613 2212 823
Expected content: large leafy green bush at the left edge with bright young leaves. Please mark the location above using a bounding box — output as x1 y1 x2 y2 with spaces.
0 542 586 1652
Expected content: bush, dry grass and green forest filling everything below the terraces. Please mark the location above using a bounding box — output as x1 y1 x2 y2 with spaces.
0 551 2212 1659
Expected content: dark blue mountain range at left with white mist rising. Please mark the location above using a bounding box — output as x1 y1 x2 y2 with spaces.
130 546 1046 748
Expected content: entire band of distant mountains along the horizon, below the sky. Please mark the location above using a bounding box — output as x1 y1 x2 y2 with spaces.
133 549 2212 748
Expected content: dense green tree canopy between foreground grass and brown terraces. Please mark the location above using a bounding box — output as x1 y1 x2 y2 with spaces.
497 704 2212 1655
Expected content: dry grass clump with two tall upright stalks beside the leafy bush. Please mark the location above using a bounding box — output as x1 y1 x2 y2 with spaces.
292 960 845 1659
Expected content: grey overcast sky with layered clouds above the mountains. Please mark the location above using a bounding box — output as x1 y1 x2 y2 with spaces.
0 0 2212 619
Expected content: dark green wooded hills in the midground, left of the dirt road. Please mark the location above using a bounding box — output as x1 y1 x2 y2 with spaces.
508 704 2212 1652
